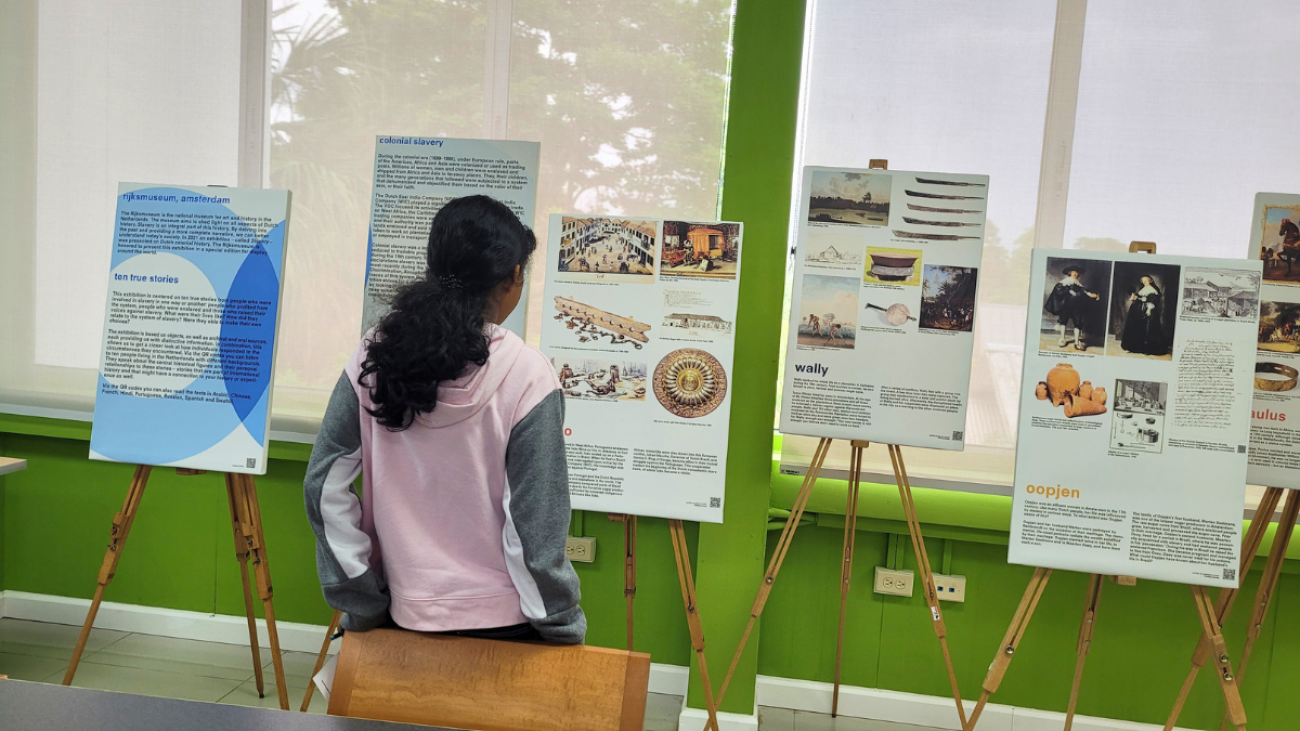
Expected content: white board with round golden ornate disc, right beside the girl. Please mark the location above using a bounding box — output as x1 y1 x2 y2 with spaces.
541 215 744 523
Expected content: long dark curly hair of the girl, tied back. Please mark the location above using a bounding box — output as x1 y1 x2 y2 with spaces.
356 195 537 432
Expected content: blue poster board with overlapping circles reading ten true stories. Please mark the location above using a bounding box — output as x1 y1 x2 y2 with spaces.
90 183 290 475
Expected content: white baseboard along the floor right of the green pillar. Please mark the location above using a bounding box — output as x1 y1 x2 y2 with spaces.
754 675 1188 731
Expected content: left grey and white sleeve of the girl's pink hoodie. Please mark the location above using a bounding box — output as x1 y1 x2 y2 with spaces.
303 372 389 631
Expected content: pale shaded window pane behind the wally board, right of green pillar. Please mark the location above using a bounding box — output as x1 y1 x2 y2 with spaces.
781 0 1056 484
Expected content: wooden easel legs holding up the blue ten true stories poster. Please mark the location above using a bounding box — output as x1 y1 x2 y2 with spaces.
64 464 289 710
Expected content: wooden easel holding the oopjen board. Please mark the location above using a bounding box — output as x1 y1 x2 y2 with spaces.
963 241 1248 731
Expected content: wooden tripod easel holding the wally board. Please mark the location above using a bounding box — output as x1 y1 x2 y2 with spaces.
718 160 970 727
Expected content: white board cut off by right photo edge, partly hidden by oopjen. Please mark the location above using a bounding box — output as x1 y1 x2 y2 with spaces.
1247 193 1300 489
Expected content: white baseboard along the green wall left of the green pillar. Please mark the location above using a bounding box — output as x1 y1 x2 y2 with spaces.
0 591 690 696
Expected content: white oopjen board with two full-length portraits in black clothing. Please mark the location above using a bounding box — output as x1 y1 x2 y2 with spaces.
1008 248 1260 587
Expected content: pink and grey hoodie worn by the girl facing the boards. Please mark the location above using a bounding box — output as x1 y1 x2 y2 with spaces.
304 325 586 644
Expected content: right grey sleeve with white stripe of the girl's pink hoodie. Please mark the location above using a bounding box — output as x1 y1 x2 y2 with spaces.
504 390 586 644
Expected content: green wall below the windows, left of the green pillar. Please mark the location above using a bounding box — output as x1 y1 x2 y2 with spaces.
0 416 698 665
